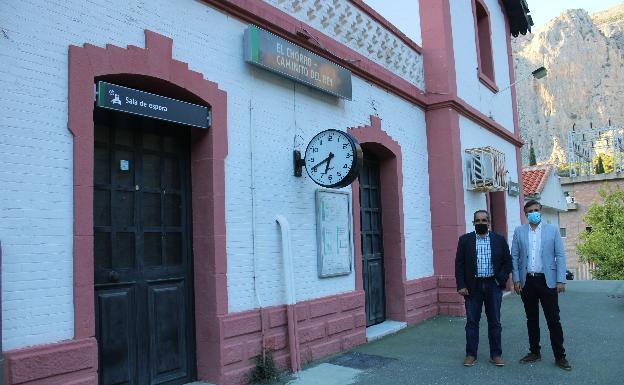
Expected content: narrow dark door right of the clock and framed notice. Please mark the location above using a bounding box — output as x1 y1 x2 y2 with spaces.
360 153 386 326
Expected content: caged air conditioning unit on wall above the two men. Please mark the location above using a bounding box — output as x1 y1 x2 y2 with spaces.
466 147 507 191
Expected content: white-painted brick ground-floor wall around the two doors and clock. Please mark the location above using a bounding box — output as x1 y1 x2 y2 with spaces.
0 0 433 349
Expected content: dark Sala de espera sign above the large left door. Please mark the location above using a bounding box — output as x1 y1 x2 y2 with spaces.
96 81 210 128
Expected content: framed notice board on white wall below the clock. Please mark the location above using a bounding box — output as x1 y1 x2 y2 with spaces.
316 189 353 278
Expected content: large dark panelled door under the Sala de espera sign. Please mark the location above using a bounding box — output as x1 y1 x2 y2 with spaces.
93 110 195 385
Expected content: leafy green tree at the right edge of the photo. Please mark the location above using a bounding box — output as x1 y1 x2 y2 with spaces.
576 188 624 279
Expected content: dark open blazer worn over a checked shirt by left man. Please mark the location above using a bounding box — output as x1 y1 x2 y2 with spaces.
455 231 512 292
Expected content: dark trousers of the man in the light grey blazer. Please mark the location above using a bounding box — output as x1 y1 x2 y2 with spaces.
521 275 565 359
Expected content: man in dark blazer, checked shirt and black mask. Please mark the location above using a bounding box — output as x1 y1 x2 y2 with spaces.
455 210 511 366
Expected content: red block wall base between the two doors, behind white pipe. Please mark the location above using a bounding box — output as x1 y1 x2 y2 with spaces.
218 290 366 385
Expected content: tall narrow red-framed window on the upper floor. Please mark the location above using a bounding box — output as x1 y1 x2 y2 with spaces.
473 0 497 88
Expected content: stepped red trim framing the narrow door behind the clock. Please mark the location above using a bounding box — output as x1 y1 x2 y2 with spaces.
348 115 407 321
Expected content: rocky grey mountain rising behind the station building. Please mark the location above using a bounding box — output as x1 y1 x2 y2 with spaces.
512 3 624 165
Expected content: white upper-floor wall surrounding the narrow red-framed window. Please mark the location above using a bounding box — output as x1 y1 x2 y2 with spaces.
449 0 514 132
